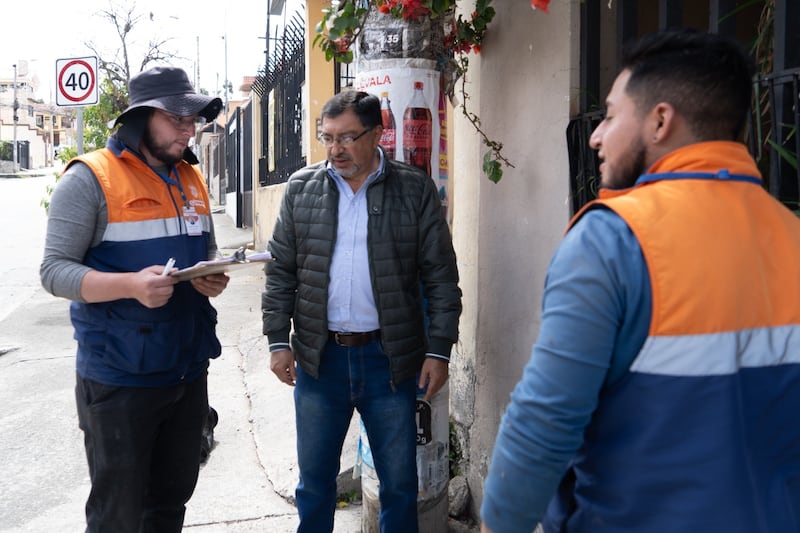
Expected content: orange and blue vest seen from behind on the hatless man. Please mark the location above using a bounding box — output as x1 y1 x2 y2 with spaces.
563 142 800 533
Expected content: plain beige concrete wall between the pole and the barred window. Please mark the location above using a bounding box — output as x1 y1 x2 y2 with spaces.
450 0 579 513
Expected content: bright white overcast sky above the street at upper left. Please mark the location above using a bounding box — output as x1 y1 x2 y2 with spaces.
0 0 284 102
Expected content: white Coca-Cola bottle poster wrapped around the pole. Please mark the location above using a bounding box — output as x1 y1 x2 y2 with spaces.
354 65 448 216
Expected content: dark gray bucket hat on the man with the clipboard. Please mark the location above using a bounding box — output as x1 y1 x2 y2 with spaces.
108 67 222 128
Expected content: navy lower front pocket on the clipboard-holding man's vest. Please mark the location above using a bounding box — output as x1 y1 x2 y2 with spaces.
102 317 181 374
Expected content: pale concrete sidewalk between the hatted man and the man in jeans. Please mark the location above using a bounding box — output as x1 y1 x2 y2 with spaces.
184 212 361 533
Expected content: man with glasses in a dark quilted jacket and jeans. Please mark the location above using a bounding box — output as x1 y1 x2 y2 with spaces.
262 91 461 533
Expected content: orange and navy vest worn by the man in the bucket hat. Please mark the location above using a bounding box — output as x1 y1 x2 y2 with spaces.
71 138 221 387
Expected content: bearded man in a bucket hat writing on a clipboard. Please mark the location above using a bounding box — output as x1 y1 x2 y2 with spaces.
40 67 228 533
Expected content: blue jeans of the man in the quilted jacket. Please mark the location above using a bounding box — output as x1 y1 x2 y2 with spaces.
294 342 417 533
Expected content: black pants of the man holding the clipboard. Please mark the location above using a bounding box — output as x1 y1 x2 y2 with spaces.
75 375 208 533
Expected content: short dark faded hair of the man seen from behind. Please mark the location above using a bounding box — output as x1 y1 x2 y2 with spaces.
622 29 753 141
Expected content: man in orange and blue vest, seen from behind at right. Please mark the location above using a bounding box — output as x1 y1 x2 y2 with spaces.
481 30 800 533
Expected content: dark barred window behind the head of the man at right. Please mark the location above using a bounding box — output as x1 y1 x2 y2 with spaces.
566 0 800 214
